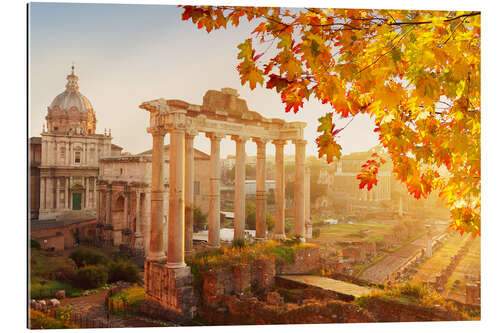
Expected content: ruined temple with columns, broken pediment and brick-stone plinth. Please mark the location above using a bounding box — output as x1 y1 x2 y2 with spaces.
140 88 306 318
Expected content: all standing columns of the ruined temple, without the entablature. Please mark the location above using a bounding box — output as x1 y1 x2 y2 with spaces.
148 128 306 268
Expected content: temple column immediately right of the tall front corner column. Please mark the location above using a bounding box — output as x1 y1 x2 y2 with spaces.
184 132 197 252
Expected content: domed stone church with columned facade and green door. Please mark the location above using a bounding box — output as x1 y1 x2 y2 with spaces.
30 66 122 222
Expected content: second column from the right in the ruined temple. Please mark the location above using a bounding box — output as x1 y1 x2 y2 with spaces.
273 140 286 239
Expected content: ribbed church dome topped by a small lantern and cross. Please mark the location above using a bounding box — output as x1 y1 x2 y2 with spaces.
45 66 97 135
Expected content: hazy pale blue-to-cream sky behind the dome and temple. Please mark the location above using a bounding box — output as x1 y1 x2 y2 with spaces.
29 3 377 156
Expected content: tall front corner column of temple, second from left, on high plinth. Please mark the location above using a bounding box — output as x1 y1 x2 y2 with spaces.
167 128 186 268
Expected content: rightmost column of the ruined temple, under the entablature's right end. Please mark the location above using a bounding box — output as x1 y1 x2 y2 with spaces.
294 140 307 240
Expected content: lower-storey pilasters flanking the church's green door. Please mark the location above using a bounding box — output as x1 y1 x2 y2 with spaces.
40 176 97 210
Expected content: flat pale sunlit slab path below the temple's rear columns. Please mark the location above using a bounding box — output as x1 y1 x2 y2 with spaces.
279 275 371 297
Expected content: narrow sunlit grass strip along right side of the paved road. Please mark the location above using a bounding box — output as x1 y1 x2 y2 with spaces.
412 233 471 282
